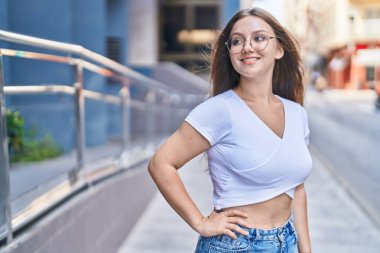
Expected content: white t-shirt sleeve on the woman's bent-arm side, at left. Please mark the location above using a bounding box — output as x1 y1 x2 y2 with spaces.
185 97 231 146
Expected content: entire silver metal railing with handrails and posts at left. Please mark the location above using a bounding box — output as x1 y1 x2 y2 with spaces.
0 30 205 245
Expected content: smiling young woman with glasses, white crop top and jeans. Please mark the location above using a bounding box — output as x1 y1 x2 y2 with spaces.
149 8 312 253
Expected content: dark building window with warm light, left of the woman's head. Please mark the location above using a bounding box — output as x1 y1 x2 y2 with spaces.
160 0 221 66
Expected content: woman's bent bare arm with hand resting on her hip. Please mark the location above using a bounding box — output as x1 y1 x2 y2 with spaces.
148 122 249 238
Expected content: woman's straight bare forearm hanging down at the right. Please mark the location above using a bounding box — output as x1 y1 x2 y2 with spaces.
293 184 311 253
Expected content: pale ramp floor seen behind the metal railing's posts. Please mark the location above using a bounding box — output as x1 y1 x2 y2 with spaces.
9 135 167 228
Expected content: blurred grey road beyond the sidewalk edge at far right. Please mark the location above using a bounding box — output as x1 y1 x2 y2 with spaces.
307 87 380 227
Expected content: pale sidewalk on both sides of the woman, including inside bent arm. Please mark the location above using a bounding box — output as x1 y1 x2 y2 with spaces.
118 87 380 253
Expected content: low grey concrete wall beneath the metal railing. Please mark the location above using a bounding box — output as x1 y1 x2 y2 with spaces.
0 163 156 253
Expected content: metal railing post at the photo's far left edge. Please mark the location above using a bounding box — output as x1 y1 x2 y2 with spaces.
0 49 12 243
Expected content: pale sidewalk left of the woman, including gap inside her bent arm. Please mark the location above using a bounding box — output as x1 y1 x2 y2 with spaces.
118 154 213 253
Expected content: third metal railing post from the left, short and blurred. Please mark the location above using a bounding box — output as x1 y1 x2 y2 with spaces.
120 87 131 154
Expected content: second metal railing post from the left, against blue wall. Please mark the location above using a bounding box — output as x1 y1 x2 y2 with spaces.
72 60 86 181
